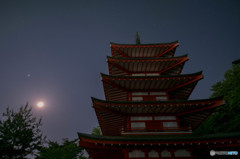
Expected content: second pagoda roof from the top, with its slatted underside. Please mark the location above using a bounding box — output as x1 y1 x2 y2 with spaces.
107 54 188 75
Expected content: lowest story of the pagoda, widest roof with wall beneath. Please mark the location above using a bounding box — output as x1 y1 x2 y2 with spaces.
78 132 240 159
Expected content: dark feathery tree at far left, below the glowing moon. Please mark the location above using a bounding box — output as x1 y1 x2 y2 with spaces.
0 104 45 159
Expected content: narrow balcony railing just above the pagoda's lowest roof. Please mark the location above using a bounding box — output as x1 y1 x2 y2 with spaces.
121 127 192 135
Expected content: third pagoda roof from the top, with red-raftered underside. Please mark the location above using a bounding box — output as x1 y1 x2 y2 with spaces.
101 71 203 101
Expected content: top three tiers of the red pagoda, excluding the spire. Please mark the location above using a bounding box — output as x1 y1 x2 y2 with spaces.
101 41 203 101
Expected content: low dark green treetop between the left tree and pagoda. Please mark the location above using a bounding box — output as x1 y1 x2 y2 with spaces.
36 139 87 159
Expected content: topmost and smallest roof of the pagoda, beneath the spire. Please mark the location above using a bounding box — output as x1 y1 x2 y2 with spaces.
110 41 179 57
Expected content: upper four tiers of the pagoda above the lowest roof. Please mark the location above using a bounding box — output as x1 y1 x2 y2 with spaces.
92 36 223 136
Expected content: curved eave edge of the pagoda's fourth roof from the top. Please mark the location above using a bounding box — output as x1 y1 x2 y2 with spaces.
92 95 224 117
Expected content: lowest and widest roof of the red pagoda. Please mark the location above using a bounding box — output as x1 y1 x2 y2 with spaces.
78 132 240 149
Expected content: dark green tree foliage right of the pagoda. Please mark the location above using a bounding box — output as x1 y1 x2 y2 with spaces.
196 60 240 134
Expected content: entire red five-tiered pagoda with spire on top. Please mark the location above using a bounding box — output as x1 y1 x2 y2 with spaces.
78 33 240 159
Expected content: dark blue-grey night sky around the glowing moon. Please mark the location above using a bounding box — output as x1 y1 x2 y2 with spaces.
0 0 240 141
